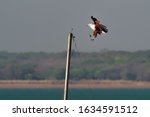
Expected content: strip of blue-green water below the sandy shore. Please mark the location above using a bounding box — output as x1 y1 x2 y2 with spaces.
0 88 150 100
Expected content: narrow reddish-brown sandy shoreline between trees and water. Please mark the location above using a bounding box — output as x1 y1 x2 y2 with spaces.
0 80 150 88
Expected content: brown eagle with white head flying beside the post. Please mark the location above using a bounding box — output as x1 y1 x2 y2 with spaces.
88 16 108 38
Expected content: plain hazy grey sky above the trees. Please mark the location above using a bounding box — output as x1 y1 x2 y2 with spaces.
0 0 150 52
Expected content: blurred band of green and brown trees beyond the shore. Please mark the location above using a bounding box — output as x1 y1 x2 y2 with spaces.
0 50 150 81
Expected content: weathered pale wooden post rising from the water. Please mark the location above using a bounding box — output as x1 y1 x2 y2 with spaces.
64 33 73 100
